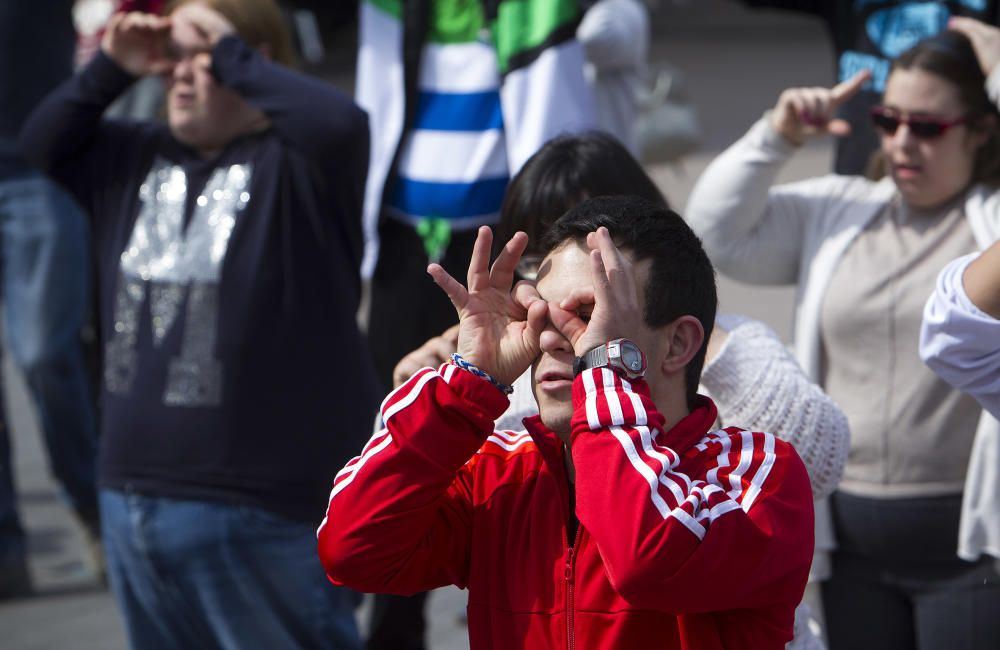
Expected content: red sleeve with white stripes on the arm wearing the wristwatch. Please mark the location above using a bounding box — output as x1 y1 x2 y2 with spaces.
572 369 813 614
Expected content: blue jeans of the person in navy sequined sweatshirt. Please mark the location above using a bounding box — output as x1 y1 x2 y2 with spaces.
100 490 361 650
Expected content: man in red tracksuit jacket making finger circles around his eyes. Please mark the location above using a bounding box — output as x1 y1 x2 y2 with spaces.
318 197 813 650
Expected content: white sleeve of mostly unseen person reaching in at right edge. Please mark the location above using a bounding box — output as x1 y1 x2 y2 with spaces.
920 253 1000 417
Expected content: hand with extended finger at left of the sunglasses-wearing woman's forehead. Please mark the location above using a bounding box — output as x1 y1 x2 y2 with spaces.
771 70 871 146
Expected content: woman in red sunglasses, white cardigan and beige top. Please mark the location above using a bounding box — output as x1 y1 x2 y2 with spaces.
687 19 1000 650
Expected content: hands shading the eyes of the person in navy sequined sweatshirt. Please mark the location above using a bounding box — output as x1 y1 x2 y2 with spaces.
101 2 236 77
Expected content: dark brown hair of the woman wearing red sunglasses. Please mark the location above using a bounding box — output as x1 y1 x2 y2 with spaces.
890 30 1000 186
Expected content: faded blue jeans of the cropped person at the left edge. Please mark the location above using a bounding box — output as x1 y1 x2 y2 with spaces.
0 174 97 557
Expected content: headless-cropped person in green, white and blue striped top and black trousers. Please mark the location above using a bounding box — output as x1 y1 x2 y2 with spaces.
356 0 594 650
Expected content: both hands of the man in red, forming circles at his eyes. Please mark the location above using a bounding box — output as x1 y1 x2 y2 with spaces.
424 226 642 384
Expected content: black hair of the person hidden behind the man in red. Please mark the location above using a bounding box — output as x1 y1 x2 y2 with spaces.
496 131 667 252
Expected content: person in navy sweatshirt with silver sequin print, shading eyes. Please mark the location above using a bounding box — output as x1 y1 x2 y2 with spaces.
22 0 378 650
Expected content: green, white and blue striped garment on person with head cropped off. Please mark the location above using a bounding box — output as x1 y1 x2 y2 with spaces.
356 0 593 277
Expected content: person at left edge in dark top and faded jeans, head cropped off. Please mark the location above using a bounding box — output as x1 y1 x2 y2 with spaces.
0 0 104 599
